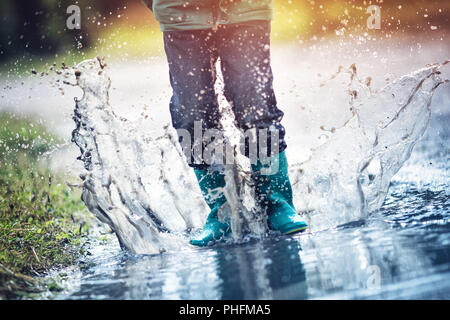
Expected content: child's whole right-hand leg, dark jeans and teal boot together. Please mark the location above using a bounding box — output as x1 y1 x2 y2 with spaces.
218 22 308 234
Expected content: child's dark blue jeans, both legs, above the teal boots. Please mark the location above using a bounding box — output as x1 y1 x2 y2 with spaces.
164 21 286 168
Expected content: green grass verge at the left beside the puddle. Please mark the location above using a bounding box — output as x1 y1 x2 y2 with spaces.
0 113 91 298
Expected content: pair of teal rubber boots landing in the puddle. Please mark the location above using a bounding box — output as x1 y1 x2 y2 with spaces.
190 151 308 247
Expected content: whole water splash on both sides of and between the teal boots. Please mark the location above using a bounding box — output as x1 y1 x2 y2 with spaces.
72 60 442 254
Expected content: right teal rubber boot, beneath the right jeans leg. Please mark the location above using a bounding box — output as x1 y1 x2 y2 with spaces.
252 151 308 234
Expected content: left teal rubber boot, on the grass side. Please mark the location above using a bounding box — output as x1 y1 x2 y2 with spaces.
190 169 231 247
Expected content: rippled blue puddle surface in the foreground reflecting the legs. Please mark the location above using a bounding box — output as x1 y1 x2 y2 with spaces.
57 109 450 299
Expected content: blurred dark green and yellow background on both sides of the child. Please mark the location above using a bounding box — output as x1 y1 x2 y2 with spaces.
0 0 450 71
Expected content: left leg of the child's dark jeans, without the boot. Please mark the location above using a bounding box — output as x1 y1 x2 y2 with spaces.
164 30 220 169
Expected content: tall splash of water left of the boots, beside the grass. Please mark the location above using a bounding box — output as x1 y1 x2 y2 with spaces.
72 60 207 253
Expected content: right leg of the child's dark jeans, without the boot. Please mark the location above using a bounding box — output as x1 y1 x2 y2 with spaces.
217 21 286 159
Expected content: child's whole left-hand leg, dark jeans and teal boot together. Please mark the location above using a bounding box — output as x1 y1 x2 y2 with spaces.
164 30 230 246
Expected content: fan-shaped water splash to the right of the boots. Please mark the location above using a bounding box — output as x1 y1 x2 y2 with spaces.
290 64 443 230
